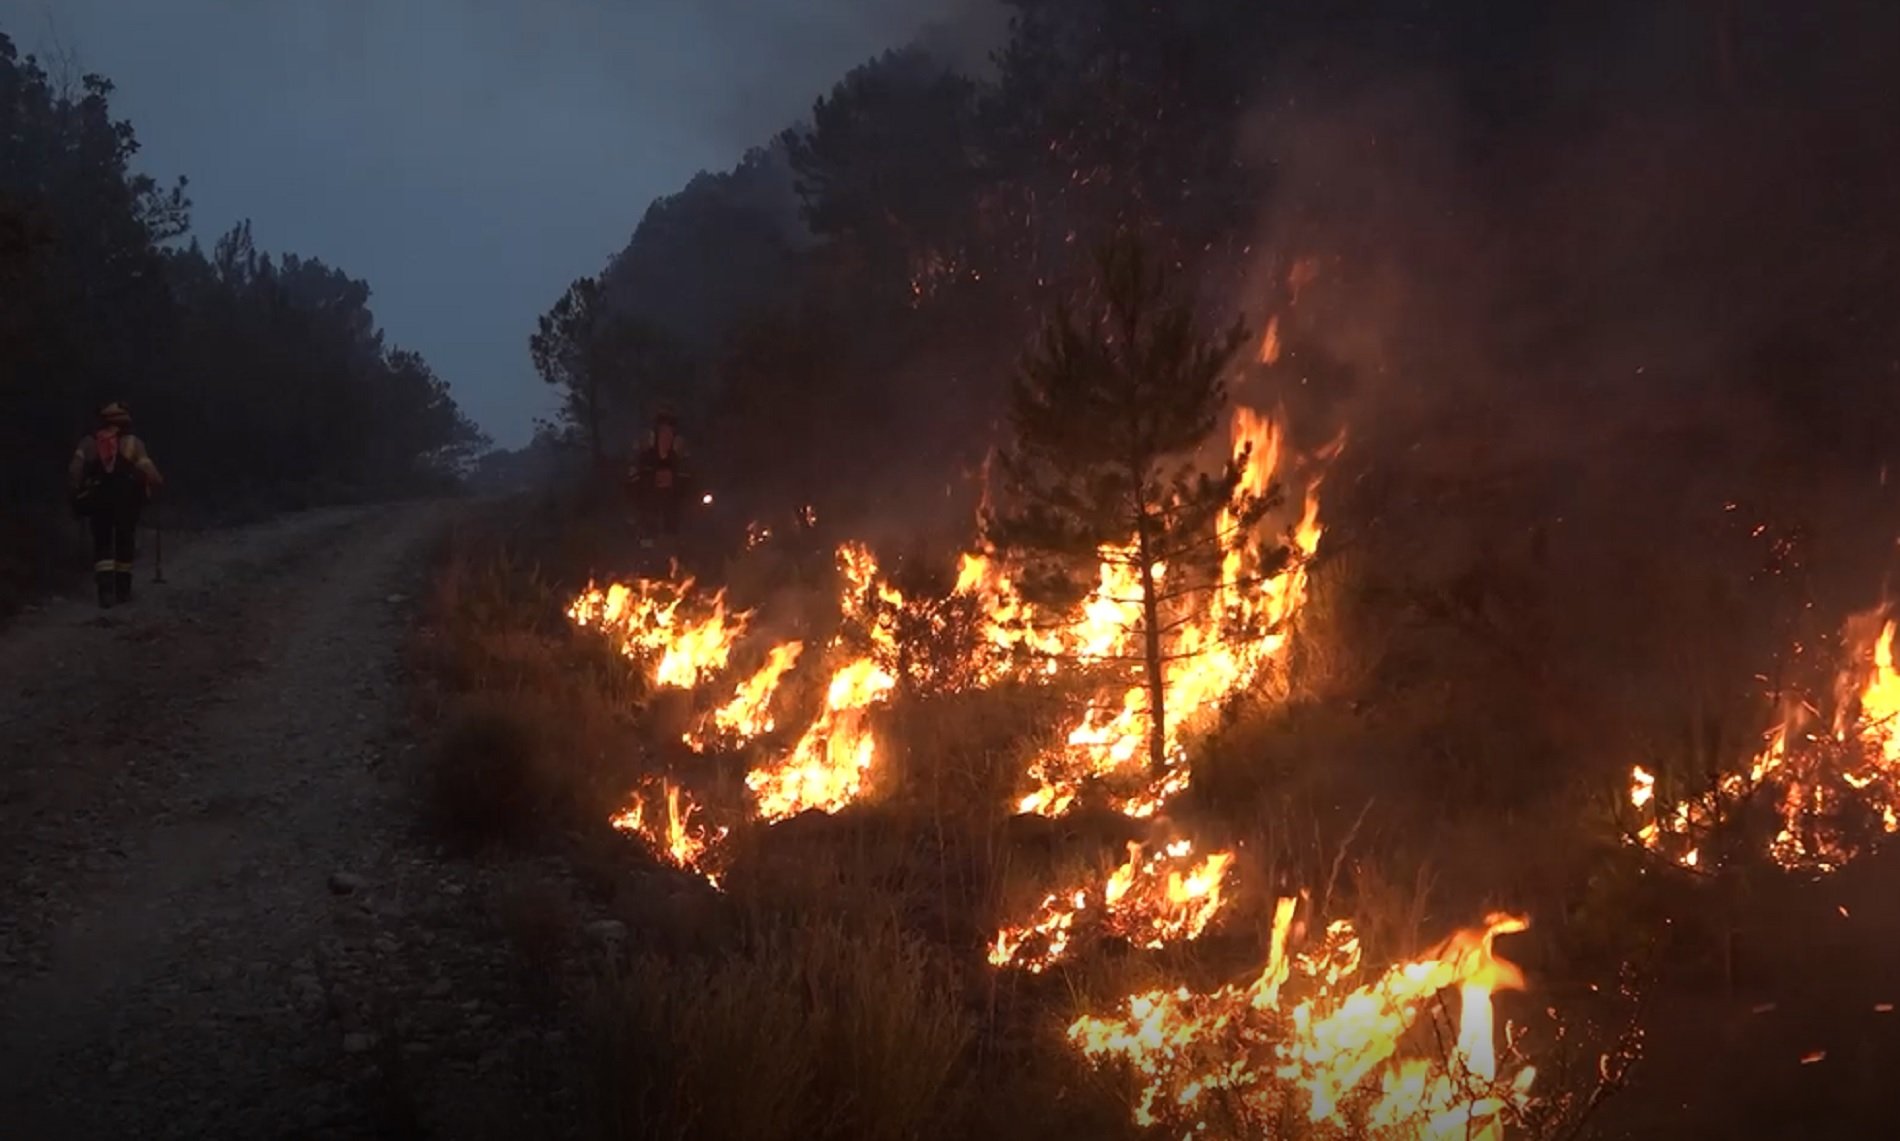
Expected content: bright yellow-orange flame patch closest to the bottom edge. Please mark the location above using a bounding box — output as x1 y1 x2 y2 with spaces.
1068 898 1535 1139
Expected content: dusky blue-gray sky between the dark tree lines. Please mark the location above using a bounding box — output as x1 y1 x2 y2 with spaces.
0 0 986 446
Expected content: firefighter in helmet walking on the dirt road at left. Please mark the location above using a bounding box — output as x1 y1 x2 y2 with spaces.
67 402 165 608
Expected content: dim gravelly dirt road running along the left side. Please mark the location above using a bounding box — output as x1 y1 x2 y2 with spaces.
0 503 562 1141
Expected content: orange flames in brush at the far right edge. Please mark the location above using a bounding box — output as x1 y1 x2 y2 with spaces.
1630 604 1900 871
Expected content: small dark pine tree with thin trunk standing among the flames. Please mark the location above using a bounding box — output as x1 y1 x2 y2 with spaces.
982 239 1273 771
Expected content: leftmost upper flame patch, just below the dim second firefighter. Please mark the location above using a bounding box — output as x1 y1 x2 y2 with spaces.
568 579 751 689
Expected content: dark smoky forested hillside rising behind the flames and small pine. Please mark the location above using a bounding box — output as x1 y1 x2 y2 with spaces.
538 0 1900 569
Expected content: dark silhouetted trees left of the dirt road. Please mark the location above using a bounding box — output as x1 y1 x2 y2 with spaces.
0 34 483 603
